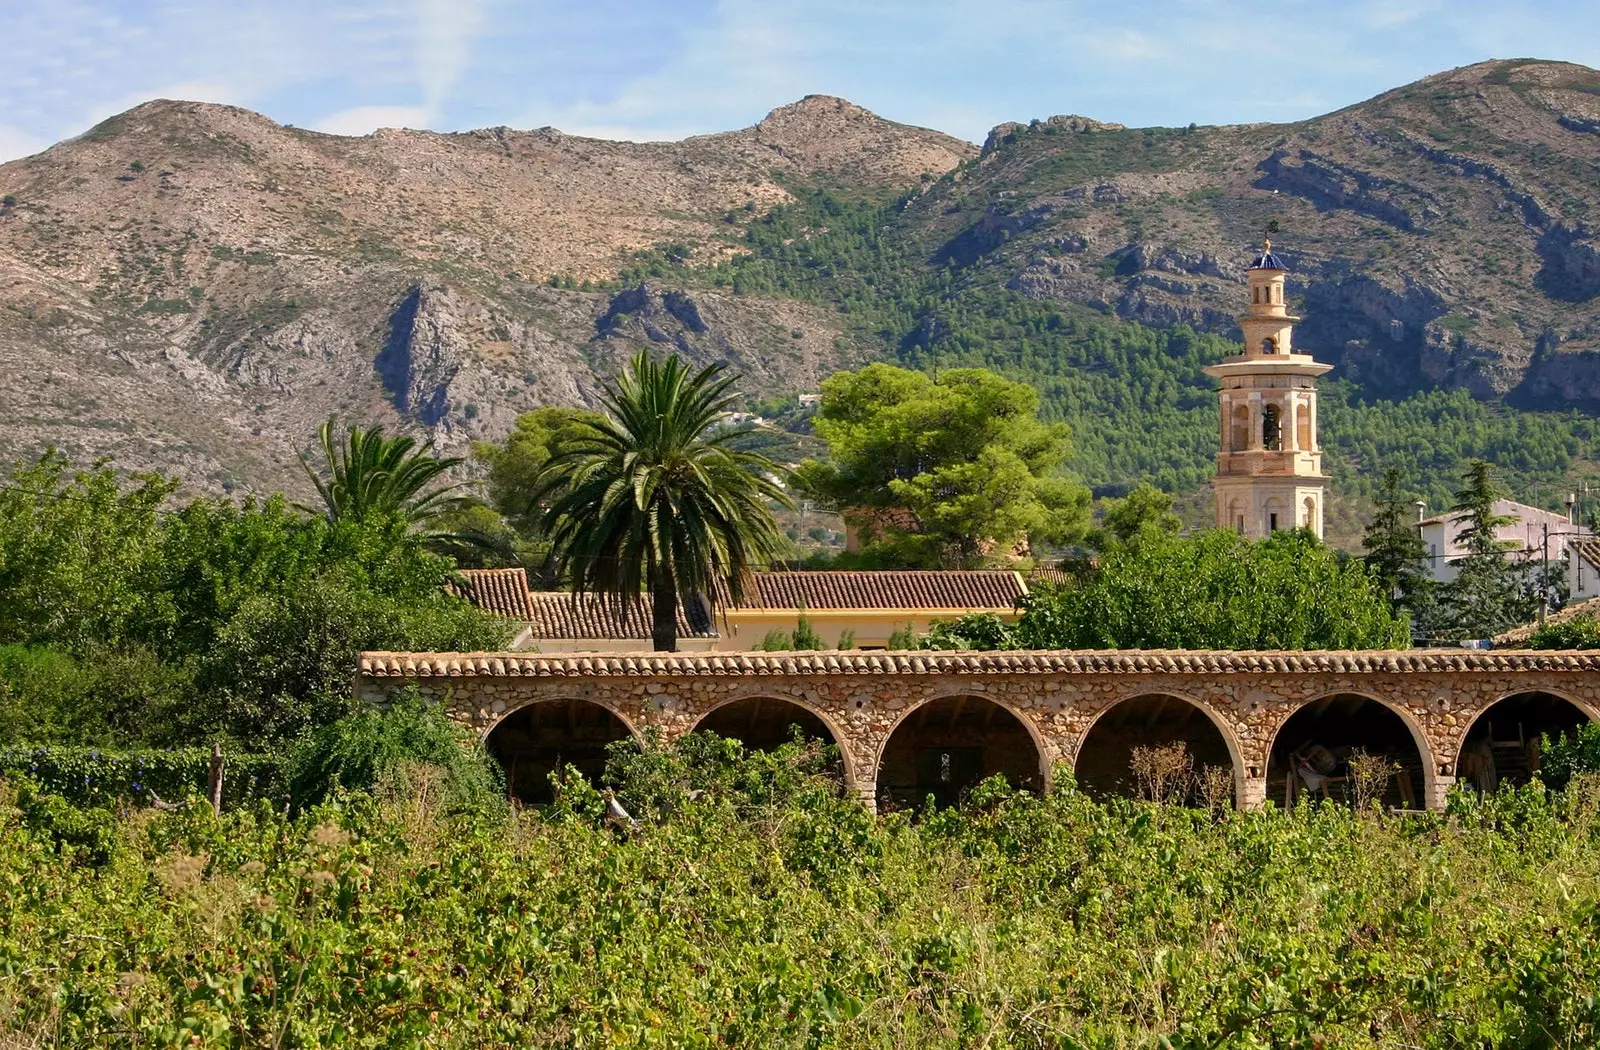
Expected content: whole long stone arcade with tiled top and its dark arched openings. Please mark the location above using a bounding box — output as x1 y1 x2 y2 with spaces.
355 650 1600 808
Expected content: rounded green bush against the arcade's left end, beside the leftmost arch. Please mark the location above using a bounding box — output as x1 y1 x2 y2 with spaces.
288 691 504 812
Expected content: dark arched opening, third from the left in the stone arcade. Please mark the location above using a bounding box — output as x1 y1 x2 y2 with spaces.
874 690 1053 807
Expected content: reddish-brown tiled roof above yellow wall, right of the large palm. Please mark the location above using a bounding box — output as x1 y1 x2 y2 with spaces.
736 570 1027 611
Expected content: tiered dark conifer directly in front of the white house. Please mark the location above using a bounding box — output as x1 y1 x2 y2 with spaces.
1438 459 1536 639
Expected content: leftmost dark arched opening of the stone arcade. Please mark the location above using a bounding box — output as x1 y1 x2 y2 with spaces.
483 696 642 804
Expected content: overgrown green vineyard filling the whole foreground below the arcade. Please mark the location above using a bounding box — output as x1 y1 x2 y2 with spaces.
9 755 1600 1050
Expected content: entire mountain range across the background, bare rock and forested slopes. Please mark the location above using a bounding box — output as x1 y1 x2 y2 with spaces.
0 59 1600 520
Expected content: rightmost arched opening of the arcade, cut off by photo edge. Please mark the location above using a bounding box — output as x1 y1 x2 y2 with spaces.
1454 688 1600 791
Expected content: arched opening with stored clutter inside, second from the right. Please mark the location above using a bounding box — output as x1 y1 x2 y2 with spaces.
1266 690 1443 808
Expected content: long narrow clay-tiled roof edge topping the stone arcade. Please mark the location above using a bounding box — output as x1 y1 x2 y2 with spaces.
360 650 1600 679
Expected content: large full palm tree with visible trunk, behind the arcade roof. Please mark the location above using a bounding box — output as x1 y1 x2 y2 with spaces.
539 351 790 651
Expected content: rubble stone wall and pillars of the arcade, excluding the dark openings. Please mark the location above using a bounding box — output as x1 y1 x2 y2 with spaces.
355 650 1600 808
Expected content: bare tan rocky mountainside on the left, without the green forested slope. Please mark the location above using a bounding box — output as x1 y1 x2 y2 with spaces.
0 96 976 490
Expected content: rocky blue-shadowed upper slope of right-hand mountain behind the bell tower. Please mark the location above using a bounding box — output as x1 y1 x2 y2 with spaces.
906 61 1600 407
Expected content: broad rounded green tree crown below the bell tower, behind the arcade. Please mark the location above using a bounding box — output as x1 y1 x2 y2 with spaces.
1011 530 1408 650
